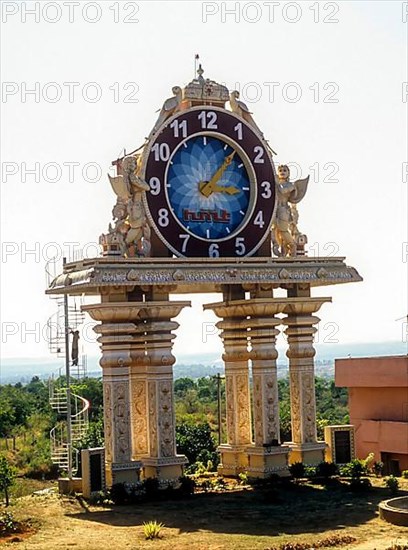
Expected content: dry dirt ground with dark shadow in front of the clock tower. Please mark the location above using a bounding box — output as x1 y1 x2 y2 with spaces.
0 483 408 550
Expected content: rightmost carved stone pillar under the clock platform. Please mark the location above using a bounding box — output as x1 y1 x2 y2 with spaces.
283 297 331 464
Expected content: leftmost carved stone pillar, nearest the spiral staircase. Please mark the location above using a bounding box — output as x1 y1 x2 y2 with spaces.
83 302 142 486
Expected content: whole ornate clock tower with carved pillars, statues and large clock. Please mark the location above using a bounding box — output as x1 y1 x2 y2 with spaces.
47 66 362 483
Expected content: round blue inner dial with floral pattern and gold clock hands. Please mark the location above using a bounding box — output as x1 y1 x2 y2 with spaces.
166 135 251 240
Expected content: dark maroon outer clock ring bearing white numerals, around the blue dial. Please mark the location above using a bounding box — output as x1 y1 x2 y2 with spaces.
142 106 275 258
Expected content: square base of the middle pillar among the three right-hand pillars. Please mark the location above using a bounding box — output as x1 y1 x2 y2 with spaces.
245 445 290 478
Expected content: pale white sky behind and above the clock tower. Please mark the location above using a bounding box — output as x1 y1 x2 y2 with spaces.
0 0 408 366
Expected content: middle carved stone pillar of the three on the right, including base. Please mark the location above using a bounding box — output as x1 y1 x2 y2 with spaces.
246 298 289 477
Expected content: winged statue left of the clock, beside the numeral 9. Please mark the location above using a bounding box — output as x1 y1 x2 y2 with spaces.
103 157 151 257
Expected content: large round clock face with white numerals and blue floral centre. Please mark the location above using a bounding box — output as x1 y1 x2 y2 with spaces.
144 107 275 257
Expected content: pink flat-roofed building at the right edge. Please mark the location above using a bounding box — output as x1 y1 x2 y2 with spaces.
335 355 408 473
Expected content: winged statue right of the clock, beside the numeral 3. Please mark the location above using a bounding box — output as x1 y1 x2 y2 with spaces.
272 164 309 256
